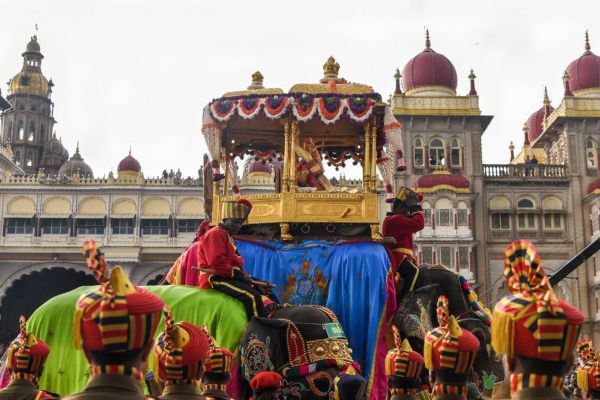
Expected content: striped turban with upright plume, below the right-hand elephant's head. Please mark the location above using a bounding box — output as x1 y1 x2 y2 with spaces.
423 296 479 374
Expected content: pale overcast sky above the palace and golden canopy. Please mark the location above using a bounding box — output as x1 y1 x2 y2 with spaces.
0 0 600 176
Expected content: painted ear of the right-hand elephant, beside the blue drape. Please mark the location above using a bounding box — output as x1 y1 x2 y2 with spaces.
392 284 440 339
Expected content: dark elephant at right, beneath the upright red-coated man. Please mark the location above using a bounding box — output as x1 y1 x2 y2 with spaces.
392 266 504 389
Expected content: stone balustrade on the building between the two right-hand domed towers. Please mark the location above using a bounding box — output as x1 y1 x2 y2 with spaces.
483 164 569 180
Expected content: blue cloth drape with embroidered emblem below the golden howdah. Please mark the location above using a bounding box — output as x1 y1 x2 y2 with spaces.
236 240 390 386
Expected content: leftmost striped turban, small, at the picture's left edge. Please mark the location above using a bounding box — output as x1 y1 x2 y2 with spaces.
6 316 50 376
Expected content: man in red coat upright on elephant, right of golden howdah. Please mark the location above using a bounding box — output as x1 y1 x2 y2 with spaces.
382 187 425 299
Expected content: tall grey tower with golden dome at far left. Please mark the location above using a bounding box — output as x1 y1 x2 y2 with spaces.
0 36 58 173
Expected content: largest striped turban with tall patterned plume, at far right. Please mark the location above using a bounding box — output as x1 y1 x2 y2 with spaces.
492 240 584 361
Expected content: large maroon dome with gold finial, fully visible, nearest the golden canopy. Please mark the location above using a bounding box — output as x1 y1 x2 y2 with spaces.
402 32 458 93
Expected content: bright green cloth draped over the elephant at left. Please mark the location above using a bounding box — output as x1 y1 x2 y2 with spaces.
27 286 247 396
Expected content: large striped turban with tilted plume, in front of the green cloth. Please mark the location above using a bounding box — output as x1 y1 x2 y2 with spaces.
73 240 163 352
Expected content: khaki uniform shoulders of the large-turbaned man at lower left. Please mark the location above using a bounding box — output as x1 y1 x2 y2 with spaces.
63 374 152 400
